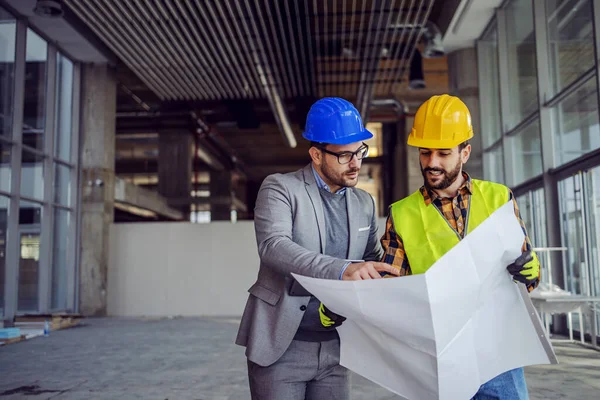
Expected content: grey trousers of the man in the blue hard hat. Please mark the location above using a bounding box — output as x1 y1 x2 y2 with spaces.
248 340 350 400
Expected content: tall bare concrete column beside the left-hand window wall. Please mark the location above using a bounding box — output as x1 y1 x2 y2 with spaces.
79 64 117 316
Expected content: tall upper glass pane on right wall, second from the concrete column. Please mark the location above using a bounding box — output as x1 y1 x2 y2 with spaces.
506 0 538 129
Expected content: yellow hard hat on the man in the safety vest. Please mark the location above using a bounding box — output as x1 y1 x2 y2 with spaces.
408 94 473 149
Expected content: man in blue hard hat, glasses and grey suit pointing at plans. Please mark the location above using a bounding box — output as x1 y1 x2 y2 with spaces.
236 98 399 400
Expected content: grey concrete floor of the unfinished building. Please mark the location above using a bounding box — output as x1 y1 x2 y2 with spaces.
0 318 600 400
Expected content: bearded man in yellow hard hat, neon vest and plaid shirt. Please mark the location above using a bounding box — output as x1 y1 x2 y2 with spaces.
381 94 540 400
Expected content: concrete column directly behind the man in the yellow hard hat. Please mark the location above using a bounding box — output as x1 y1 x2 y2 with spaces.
448 47 483 179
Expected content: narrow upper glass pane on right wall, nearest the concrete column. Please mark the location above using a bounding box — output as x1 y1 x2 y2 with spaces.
477 25 502 148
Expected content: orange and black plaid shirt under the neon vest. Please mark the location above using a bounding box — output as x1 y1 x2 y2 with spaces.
381 172 539 292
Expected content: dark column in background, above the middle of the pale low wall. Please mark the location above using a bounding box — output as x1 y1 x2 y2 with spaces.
158 132 194 212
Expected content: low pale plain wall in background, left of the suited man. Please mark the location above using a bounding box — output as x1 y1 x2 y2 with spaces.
107 218 385 316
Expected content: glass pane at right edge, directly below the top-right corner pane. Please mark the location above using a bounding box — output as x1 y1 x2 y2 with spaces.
552 77 600 165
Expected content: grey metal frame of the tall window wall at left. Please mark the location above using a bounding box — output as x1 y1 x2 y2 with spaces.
0 7 81 320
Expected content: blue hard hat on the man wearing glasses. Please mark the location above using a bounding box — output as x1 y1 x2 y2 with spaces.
302 97 373 144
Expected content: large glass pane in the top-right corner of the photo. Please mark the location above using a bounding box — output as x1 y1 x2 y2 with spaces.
546 0 594 94
